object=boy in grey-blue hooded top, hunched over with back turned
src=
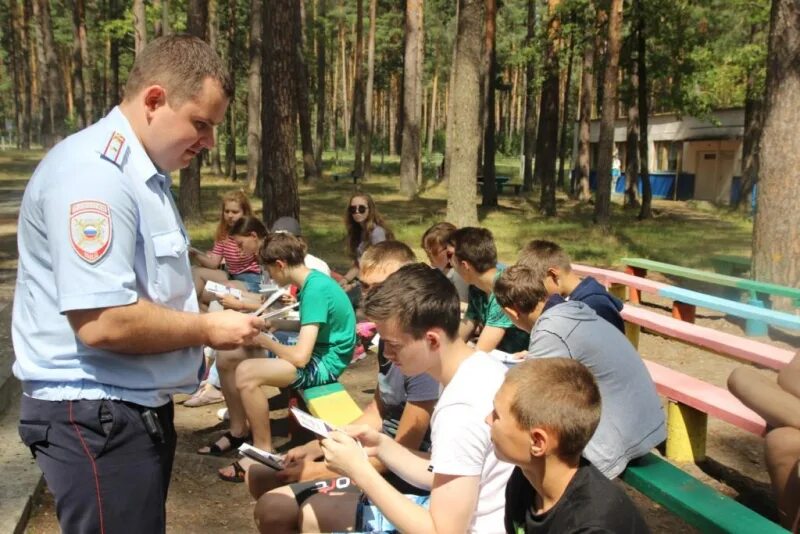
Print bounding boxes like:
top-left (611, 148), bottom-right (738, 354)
top-left (494, 265), bottom-right (667, 478)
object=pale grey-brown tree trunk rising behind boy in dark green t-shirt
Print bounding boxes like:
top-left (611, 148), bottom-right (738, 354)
top-left (445, 0), bottom-right (483, 227)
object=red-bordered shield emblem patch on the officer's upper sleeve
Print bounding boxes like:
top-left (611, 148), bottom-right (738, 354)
top-left (69, 200), bottom-right (111, 263)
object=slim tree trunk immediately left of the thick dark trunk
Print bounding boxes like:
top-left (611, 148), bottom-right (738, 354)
top-left (247, 0), bottom-right (263, 193)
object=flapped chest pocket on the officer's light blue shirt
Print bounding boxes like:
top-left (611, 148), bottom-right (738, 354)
top-left (150, 228), bottom-right (194, 303)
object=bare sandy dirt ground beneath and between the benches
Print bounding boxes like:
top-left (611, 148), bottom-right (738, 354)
top-left (27, 302), bottom-right (800, 534)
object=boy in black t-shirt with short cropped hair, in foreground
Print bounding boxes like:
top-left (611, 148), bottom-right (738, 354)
top-left (487, 358), bottom-right (649, 534)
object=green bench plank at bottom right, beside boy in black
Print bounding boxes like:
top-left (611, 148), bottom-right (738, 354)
top-left (621, 453), bottom-right (787, 534)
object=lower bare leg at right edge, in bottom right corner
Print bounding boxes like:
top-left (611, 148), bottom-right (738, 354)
top-left (765, 427), bottom-right (800, 529)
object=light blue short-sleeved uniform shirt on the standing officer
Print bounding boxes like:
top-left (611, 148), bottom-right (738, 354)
top-left (12, 108), bottom-right (203, 407)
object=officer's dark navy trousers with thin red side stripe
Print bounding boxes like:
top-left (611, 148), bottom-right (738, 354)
top-left (19, 396), bottom-right (177, 534)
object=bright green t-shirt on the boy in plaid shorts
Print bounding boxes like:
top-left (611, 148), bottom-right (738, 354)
top-left (297, 270), bottom-right (356, 377)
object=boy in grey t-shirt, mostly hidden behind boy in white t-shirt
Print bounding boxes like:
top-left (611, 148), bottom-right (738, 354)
top-left (247, 241), bottom-right (439, 533)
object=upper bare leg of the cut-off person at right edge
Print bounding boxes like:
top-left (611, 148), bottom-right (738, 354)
top-left (728, 366), bottom-right (800, 428)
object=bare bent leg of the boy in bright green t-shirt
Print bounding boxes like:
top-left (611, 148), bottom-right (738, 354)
top-left (239, 358), bottom-right (297, 451)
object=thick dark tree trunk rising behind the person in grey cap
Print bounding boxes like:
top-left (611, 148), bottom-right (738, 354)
top-left (261, 0), bottom-right (300, 227)
